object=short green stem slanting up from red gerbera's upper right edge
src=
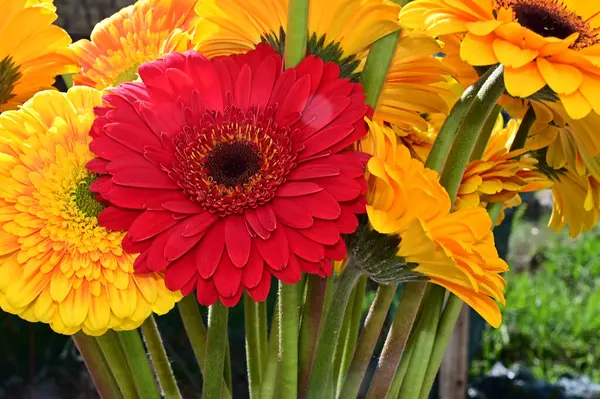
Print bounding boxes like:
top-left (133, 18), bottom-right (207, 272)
top-left (361, 31), bottom-right (400, 108)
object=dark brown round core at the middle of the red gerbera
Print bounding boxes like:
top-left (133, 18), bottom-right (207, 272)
top-left (206, 142), bottom-right (260, 187)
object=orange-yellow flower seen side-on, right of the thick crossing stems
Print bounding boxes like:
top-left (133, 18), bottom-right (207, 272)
top-left (454, 115), bottom-right (552, 209)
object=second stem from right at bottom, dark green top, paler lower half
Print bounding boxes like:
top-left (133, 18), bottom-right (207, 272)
top-left (399, 285), bottom-right (446, 399)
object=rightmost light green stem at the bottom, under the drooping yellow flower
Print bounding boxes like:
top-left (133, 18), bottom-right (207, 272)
top-left (418, 294), bottom-right (464, 399)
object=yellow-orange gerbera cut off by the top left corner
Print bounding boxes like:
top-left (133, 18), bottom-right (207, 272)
top-left (0, 0), bottom-right (77, 112)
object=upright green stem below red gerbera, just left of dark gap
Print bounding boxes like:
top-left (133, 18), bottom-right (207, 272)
top-left (202, 301), bottom-right (229, 399)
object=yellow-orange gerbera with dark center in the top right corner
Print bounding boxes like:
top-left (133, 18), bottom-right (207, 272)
top-left (400, 0), bottom-right (600, 119)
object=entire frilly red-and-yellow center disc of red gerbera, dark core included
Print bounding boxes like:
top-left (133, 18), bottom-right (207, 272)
top-left (171, 106), bottom-right (296, 216)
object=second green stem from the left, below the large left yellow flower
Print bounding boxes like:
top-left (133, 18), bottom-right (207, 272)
top-left (96, 330), bottom-right (138, 399)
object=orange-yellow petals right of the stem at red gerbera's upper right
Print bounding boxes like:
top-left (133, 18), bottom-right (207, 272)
top-left (374, 33), bottom-right (454, 132)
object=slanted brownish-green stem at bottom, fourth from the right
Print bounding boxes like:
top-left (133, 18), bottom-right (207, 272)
top-left (339, 284), bottom-right (398, 399)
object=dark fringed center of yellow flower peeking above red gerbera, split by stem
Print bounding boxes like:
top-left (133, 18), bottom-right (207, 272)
top-left (261, 28), bottom-right (360, 82)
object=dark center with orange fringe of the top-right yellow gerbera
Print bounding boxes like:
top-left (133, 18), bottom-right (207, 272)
top-left (495, 0), bottom-right (600, 49)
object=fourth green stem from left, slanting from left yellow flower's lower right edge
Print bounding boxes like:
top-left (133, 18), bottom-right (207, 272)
top-left (141, 315), bottom-right (181, 399)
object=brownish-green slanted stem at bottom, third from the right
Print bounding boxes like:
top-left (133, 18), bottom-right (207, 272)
top-left (367, 282), bottom-right (426, 399)
